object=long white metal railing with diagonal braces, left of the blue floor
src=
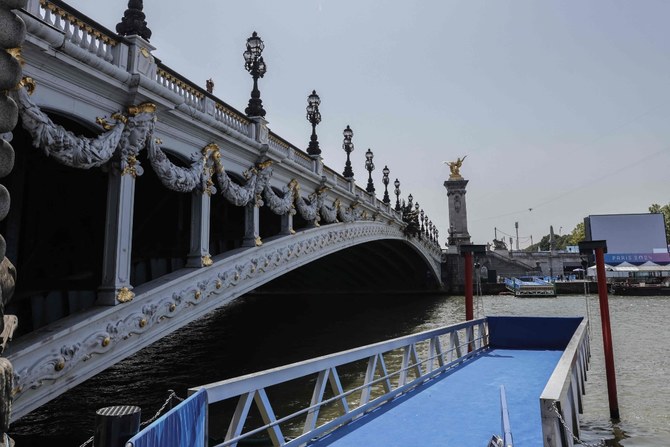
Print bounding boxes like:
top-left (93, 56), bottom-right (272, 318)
top-left (189, 318), bottom-right (488, 447)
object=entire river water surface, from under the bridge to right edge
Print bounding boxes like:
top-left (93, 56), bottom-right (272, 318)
top-left (10, 294), bottom-right (670, 447)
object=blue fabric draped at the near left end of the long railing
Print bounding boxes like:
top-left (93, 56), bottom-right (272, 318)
top-left (128, 390), bottom-right (207, 447)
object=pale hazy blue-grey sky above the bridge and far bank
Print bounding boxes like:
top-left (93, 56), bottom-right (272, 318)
top-left (66, 0), bottom-right (670, 248)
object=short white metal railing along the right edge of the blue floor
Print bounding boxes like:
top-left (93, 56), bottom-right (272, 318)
top-left (540, 319), bottom-right (591, 447)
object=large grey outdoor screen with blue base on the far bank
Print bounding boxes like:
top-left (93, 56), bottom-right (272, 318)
top-left (584, 214), bottom-right (668, 262)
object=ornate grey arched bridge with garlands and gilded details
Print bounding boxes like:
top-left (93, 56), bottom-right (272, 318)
top-left (2, 0), bottom-right (440, 420)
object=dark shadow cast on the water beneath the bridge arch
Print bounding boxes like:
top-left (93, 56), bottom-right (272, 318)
top-left (10, 293), bottom-right (452, 447)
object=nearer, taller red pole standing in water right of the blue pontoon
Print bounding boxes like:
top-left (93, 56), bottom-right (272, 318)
top-left (595, 248), bottom-right (619, 419)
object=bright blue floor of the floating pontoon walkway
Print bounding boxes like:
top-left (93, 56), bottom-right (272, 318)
top-left (310, 349), bottom-right (563, 447)
